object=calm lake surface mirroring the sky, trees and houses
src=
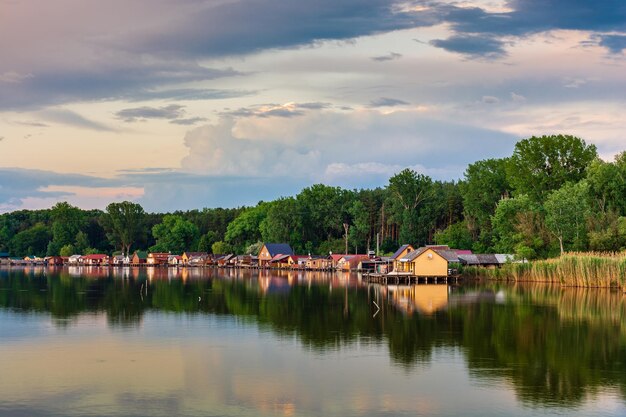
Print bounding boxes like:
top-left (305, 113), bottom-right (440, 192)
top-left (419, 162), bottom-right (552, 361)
top-left (0, 268), bottom-right (626, 417)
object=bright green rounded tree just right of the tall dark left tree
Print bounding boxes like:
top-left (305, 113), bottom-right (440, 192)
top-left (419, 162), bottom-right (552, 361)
top-left (150, 214), bottom-right (199, 253)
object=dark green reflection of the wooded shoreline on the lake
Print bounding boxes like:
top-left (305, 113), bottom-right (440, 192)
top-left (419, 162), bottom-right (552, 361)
top-left (0, 268), bottom-right (626, 406)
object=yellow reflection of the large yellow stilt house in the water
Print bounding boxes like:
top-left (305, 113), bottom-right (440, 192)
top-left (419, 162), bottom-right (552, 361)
top-left (387, 284), bottom-right (448, 315)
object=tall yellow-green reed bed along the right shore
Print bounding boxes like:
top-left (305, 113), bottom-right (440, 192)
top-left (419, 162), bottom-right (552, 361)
top-left (462, 252), bottom-right (626, 289)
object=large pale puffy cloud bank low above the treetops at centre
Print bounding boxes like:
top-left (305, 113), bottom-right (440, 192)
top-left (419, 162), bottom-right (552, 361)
top-left (181, 109), bottom-right (515, 187)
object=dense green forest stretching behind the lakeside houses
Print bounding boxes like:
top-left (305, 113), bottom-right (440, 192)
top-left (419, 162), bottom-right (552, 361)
top-left (0, 135), bottom-right (626, 259)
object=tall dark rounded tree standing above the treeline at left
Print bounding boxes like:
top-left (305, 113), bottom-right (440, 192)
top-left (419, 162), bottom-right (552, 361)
top-left (100, 201), bottom-right (146, 254)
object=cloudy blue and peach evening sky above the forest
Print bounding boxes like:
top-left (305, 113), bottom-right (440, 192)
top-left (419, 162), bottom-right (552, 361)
top-left (0, 0), bottom-right (626, 212)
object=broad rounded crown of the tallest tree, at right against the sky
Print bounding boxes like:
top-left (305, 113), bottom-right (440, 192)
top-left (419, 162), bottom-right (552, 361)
top-left (506, 135), bottom-right (598, 202)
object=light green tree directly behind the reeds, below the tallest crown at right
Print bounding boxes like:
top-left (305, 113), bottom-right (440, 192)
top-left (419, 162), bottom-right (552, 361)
top-left (544, 181), bottom-right (590, 255)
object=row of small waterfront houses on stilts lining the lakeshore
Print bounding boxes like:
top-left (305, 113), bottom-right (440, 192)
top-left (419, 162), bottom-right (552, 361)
top-left (0, 243), bottom-right (512, 283)
